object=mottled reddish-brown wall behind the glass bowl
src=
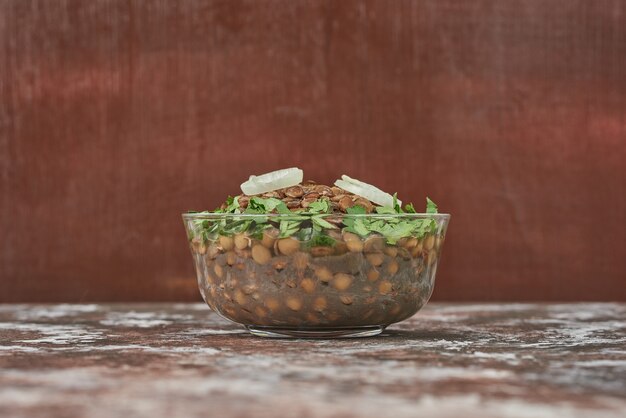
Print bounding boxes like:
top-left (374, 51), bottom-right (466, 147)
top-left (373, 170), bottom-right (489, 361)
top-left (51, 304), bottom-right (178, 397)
top-left (0, 0), bottom-right (626, 302)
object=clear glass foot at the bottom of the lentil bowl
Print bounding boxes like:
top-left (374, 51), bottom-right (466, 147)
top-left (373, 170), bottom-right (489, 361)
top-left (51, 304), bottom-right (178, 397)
top-left (245, 325), bottom-right (385, 338)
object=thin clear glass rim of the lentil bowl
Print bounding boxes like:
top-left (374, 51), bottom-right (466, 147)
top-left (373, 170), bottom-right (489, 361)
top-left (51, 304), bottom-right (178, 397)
top-left (182, 212), bottom-right (451, 220)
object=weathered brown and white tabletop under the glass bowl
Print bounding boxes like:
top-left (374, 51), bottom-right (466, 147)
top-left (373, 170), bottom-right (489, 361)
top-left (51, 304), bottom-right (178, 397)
top-left (0, 303), bottom-right (626, 418)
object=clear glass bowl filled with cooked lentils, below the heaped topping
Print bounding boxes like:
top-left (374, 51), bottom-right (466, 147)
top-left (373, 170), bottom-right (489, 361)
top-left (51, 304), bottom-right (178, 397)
top-left (183, 213), bottom-right (450, 338)
